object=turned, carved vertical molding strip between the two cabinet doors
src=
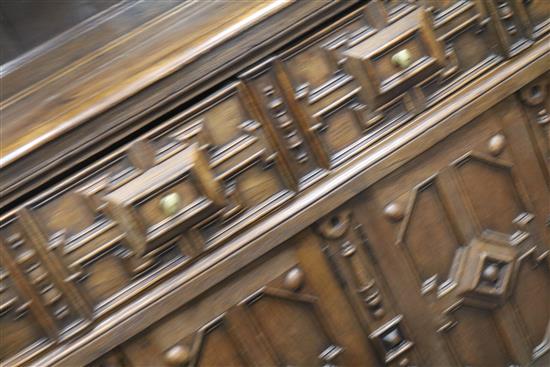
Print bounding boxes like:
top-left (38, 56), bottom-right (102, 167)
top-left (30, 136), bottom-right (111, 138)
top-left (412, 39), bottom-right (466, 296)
top-left (316, 208), bottom-right (418, 366)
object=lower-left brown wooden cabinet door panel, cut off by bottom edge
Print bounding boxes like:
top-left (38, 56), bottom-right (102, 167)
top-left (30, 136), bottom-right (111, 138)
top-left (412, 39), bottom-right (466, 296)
top-left (88, 231), bottom-right (378, 366)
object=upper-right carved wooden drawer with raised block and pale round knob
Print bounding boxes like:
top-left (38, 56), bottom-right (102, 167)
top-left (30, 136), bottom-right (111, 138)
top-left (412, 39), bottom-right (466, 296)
top-left (275, 1), bottom-right (516, 167)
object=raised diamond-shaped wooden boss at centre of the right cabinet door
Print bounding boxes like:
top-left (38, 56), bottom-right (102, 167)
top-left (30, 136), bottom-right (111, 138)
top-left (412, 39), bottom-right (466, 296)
top-left (457, 238), bottom-right (517, 308)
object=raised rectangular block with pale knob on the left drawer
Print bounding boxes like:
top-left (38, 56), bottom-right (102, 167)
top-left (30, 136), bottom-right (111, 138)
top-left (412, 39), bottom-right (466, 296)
top-left (104, 143), bottom-right (224, 256)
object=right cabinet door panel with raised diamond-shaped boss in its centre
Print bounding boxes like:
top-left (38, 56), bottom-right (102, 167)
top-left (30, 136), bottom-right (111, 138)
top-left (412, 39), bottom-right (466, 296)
top-left (358, 97), bottom-right (550, 366)
